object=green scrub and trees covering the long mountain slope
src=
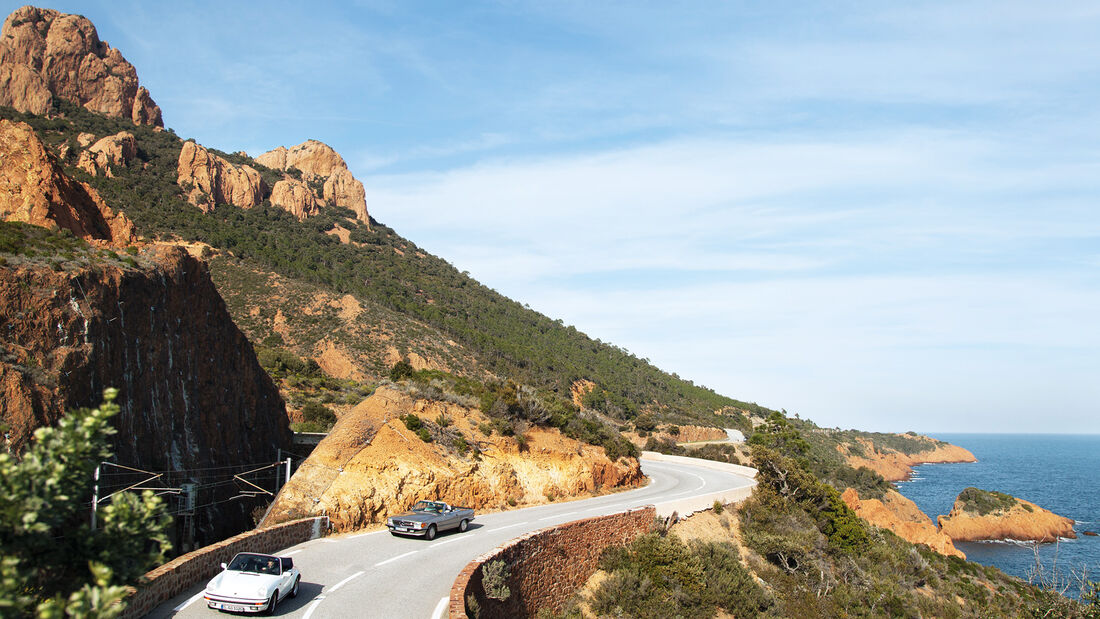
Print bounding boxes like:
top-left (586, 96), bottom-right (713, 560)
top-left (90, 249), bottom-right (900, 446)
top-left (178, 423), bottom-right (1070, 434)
top-left (0, 100), bottom-right (767, 425)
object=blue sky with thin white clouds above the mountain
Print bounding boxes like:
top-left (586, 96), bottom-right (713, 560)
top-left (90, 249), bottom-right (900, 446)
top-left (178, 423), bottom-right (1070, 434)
top-left (19, 1), bottom-right (1100, 432)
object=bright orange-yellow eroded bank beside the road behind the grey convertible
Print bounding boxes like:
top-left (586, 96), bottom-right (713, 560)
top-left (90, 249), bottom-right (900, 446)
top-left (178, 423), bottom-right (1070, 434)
top-left (267, 387), bottom-right (642, 530)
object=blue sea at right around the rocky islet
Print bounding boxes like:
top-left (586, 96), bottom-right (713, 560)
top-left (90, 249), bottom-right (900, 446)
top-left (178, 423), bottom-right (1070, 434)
top-left (895, 433), bottom-right (1100, 597)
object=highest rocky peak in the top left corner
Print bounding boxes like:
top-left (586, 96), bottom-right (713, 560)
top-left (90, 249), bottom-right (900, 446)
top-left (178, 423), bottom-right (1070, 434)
top-left (0, 7), bottom-right (164, 126)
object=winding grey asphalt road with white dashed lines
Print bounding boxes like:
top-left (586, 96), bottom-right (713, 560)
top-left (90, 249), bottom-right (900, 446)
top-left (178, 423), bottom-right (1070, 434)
top-left (146, 458), bottom-right (755, 619)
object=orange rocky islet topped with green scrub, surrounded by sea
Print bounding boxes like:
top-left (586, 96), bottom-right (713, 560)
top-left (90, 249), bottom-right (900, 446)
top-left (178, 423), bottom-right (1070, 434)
top-left (938, 488), bottom-right (1077, 542)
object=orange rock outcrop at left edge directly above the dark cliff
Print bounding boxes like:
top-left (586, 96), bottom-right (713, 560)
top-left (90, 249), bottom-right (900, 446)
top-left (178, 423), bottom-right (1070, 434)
top-left (0, 120), bottom-right (133, 245)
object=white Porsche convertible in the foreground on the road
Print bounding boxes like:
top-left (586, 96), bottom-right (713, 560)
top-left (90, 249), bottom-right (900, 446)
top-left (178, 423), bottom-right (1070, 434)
top-left (202, 552), bottom-right (301, 615)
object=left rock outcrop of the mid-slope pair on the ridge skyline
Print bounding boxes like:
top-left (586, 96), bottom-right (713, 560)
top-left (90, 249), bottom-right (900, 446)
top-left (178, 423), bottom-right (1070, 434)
top-left (176, 142), bottom-right (266, 212)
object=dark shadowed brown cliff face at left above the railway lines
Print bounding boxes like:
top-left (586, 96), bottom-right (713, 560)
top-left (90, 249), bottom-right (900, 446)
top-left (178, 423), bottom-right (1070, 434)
top-left (0, 245), bottom-right (292, 543)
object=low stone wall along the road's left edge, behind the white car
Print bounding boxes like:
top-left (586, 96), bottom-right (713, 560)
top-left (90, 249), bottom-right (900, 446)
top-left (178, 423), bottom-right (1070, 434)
top-left (122, 516), bottom-right (329, 619)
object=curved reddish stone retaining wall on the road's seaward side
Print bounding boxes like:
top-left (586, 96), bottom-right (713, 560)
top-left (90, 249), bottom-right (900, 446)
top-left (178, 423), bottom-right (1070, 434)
top-left (450, 506), bottom-right (657, 619)
